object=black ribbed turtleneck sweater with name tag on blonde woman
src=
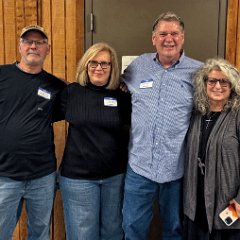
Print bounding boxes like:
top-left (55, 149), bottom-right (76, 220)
top-left (61, 83), bottom-right (131, 179)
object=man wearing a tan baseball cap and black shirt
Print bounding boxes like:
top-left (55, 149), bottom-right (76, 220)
top-left (0, 25), bottom-right (66, 240)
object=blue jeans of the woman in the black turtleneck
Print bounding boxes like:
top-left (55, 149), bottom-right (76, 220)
top-left (60, 174), bottom-right (125, 240)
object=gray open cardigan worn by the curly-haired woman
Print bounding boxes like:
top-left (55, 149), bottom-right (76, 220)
top-left (183, 110), bottom-right (240, 231)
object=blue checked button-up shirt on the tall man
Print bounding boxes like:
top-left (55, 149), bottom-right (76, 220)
top-left (123, 53), bottom-right (201, 183)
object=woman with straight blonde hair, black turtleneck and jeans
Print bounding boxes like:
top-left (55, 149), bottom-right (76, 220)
top-left (60, 43), bottom-right (131, 240)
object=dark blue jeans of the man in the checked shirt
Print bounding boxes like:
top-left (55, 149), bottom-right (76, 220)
top-left (123, 166), bottom-right (182, 240)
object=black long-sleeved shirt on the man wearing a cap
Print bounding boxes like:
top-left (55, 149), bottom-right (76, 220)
top-left (0, 64), bottom-right (66, 180)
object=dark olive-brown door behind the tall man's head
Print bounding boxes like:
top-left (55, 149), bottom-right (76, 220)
top-left (85, 0), bottom-right (227, 64)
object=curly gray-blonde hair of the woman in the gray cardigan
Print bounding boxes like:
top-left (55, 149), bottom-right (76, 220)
top-left (193, 58), bottom-right (240, 115)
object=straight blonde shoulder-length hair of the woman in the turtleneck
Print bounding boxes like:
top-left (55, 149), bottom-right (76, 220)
top-left (76, 42), bottom-right (120, 90)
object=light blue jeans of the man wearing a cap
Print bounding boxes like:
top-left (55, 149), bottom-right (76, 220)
top-left (0, 172), bottom-right (56, 240)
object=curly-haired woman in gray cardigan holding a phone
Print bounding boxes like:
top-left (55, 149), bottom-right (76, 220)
top-left (183, 58), bottom-right (240, 240)
